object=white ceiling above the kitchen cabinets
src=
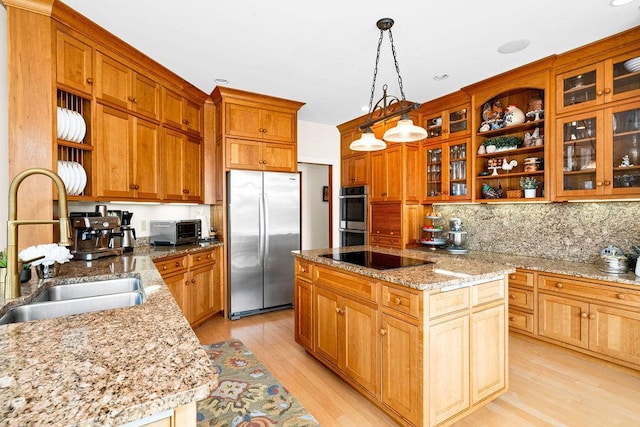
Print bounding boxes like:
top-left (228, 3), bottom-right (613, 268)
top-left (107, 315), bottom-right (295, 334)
top-left (64, 0), bottom-right (640, 125)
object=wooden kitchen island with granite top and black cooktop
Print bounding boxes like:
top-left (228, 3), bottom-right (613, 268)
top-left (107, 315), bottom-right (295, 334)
top-left (294, 246), bottom-right (515, 426)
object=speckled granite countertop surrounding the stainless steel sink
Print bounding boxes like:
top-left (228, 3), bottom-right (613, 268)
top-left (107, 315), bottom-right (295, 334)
top-left (0, 243), bottom-right (221, 426)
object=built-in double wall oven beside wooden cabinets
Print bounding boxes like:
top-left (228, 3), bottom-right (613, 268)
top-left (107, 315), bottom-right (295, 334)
top-left (339, 185), bottom-right (368, 246)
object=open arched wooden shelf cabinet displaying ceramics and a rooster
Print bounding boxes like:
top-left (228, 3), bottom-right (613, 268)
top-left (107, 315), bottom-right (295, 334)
top-left (466, 57), bottom-right (554, 202)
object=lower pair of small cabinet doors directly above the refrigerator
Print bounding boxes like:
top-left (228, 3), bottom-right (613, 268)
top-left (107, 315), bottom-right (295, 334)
top-left (226, 138), bottom-right (297, 172)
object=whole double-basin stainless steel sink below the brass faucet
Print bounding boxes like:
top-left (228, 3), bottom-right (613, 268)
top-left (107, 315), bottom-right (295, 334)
top-left (0, 278), bottom-right (146, 325)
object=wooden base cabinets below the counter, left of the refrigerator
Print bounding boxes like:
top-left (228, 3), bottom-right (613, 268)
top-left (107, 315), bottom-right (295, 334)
top-left (154, 247), bottom-right (223, 327)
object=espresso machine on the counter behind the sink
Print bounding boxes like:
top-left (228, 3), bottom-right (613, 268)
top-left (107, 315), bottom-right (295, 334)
top-left (69, 212), bottom-right (123, 260)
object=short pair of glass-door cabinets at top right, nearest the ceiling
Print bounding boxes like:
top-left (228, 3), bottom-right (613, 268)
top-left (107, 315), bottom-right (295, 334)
top-left (556, 50), bottom-right (640, 114)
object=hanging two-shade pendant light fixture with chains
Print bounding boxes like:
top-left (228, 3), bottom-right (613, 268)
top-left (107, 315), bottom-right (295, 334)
top-left (349, 18), bottom-right (427, 151)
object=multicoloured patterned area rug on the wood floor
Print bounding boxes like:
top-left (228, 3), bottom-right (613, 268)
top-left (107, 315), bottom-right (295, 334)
top-left (198, 340), bottom-right (319, 427)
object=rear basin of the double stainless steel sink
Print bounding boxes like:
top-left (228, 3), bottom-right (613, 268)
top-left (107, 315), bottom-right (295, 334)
top-left (33, 277), bottom-right (143, 302)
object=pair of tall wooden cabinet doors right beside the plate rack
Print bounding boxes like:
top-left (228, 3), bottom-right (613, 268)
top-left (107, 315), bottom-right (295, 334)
top-left (96, 104), bottom-right (160, 200)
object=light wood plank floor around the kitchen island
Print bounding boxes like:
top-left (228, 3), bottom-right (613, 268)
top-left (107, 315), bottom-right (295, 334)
top-left (195, 310), bottom-right (640, 427)
